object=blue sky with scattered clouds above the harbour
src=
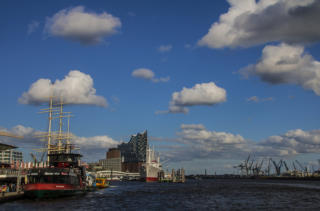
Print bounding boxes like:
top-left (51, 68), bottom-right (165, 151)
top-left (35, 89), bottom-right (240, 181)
top-left (0, 0), bottom-right (320, 173)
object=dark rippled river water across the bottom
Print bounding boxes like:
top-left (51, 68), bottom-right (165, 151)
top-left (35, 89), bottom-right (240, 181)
top-left (0, 179), bottom-right (320, 211)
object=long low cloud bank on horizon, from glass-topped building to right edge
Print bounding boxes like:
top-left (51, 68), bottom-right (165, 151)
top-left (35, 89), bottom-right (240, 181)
top-left (164, 124), bottom-right (320, 161)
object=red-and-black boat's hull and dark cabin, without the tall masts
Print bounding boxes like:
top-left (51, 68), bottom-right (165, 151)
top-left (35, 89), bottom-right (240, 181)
top-left (24, 153), bottom-right (85, 198)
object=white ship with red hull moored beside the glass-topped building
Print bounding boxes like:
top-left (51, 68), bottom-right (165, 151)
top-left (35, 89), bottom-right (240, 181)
top-left (142, 147), bottom-right (162, 182)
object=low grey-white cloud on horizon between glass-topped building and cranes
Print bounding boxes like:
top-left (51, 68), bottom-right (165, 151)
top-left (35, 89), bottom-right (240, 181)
top-left (164, 124), bottom-right (249, 161)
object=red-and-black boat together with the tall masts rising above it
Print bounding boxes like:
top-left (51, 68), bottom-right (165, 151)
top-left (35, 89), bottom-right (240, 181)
top-left (24, 97), bottom-right (86, 198)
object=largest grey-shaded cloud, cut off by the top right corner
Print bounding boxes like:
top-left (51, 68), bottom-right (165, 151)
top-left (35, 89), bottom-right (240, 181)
top-left (198, 0), bottom-right (320, 48)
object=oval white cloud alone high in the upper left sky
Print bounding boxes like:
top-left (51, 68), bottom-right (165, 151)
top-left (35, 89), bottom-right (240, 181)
top-left (45, 6), bottom-right (121, 45)
